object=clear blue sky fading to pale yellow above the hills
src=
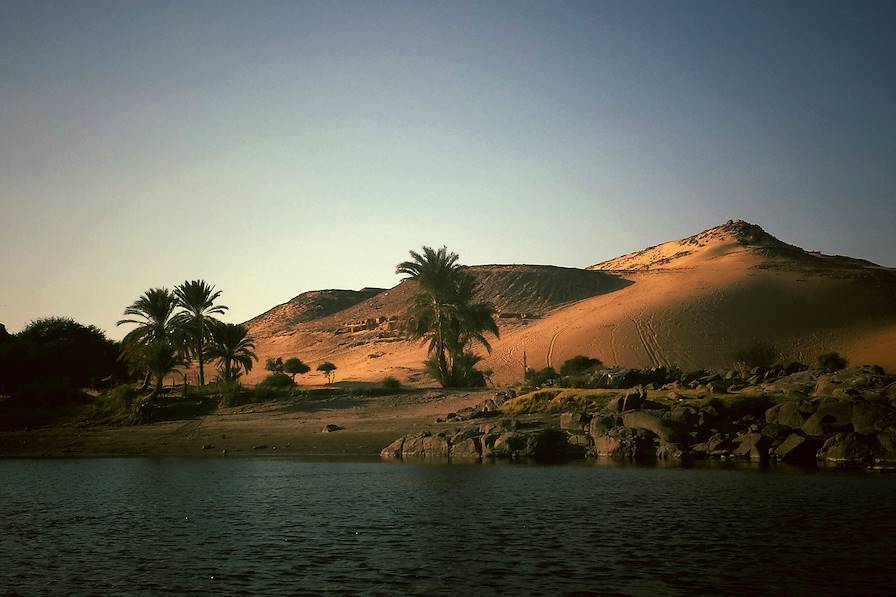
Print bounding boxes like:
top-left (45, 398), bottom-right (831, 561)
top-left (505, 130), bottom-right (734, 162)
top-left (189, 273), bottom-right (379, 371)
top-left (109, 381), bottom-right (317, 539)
top-left (0, 0), bottom-right (896, 338)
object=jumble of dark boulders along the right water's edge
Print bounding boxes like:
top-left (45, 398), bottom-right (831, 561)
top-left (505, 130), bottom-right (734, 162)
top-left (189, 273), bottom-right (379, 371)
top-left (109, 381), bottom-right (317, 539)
top-left (381, 366), bottom-right (896, 470)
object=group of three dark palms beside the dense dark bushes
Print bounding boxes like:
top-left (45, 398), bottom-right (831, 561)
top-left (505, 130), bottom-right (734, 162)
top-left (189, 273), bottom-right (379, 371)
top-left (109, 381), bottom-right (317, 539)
top-left (117, 280), bottom-right (258, 395)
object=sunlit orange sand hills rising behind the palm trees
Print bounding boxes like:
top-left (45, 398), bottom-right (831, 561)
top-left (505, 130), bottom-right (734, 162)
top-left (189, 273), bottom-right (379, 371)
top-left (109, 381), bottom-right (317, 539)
top-left (240, 221), bottom-right (896, 383)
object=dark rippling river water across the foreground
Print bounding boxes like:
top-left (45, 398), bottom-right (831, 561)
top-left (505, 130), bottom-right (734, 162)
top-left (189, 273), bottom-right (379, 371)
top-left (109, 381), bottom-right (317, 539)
top-left (0, 458), bottom-right (896, 595)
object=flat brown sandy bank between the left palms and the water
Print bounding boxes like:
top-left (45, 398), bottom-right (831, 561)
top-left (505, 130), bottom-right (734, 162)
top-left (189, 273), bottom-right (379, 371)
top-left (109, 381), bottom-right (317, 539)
top-left (0, 390), bottom-right (494, 457)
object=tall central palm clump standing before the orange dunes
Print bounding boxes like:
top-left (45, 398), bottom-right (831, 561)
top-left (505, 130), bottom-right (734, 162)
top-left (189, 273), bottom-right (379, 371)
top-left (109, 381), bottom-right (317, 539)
top-left (395, 247), bottom-right (499, 387)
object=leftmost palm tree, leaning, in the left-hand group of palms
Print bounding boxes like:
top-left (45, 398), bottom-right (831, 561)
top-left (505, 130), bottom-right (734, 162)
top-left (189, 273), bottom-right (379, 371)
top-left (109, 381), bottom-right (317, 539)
top-left (115, 288), bottom-right (177, 388)
